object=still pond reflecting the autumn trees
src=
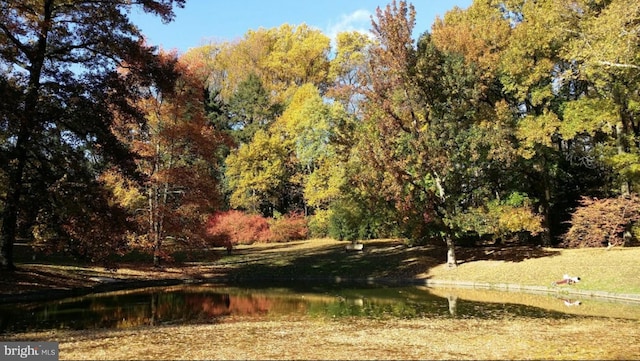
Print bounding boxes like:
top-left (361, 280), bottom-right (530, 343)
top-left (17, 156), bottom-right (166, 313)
top-left (0, 284), bottom-right (640, 334)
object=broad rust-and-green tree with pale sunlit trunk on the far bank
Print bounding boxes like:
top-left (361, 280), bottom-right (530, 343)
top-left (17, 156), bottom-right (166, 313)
top-left (363, 2), bottom-right (539, 266)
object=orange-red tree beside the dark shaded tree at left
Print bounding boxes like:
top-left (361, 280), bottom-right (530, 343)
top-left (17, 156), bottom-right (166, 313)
top-left (113, 53), bottom-right (226, 266)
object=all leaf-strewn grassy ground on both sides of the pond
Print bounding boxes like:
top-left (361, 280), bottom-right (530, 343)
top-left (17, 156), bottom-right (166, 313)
top-left (0, 240), bottom-right (640, 360)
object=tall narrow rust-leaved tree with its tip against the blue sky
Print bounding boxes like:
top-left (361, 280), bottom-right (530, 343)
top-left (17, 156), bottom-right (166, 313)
top-left (363, 1), bottom-right (468, 266)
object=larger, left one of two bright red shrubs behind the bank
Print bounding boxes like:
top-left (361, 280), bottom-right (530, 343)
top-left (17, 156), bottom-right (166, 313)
top-left (207, 210), bottom-right (269, 247)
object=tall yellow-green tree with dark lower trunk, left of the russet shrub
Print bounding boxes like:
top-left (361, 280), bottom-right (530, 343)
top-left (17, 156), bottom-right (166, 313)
top-left (495, 1), bottom-right (571, 245)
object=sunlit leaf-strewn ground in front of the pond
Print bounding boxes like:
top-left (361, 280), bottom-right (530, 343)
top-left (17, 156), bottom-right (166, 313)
top-left (8, 318), bottom-right (640, 360)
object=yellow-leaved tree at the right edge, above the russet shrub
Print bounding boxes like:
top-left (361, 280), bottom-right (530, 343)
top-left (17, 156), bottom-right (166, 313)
top-left (561, 0), bottom-right (640, 195)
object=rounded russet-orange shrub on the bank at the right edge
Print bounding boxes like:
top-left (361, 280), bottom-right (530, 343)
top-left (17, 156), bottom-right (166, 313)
top-left (563, 194), bottom-right (640, 247)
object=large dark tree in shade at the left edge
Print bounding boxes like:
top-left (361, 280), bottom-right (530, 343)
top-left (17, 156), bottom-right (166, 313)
top-left (0, 0), bottom-right (184, 269)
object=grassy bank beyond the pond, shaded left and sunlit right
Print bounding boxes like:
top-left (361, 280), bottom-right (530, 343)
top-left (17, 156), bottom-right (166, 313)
top-left (0, 239), bottom-right (640, 295)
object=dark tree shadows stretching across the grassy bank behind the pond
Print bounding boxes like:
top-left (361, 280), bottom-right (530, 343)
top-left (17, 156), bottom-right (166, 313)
top-left (0, 240), bottom-right (559, 298)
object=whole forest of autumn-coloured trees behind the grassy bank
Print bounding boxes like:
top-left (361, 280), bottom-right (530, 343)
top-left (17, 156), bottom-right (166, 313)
top-left (0, 0), bottom-right (640, 270)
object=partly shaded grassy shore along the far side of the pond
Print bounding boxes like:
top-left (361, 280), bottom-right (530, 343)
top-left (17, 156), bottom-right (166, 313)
top-left (0, 239), bottom-right (640, 304)
